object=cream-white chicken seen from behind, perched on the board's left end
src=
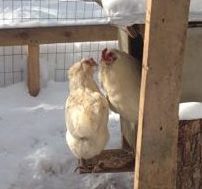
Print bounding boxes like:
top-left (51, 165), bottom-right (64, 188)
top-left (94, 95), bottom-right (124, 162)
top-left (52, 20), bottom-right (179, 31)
top-left (65, 58), bottom-right (109, 167)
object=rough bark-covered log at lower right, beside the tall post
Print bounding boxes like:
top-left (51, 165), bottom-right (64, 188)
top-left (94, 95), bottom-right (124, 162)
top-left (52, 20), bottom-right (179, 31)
top-left (177, 120), bottom-right (202, 189)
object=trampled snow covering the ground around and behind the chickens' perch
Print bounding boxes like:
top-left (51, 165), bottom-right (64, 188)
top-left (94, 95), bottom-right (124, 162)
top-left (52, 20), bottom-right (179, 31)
top-left (0, 81), bottom-right (133, 189)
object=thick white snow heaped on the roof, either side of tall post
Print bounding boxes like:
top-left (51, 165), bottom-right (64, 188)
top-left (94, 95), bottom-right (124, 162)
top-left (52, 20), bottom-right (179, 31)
top-left (102, 0), bottom-right (202, 26)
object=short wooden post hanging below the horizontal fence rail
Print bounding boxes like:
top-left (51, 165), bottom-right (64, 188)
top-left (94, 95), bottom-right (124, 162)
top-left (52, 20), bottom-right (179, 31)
top-left (27, 44), bottom-right (40, 96)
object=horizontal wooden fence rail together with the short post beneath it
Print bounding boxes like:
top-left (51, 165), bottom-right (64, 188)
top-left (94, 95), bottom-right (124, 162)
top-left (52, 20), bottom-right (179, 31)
top-left (0, 24), bottom-right (118, 96)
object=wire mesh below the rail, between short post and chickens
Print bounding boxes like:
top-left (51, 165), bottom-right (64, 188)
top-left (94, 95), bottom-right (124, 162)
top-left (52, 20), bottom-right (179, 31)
top-left (40, 41), bottom-right (118, 81)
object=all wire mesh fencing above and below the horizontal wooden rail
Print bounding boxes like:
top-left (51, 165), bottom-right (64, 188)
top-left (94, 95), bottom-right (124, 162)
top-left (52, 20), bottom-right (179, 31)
top-left (0, 0), bottom-right (118, 87)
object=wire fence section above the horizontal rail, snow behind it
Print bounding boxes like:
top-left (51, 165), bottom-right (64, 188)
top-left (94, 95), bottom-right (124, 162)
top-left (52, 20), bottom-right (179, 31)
top-left (0, 0), bottom-right (106, 27)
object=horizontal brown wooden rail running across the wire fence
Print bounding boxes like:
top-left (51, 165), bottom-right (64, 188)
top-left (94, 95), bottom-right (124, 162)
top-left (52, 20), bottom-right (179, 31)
top-left (0, 25), bottom-right (117, 46)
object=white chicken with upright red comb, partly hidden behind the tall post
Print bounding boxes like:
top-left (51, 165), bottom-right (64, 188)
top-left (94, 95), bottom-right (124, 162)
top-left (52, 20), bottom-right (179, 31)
top-left (99, 49), bottom-right (141, 134)
